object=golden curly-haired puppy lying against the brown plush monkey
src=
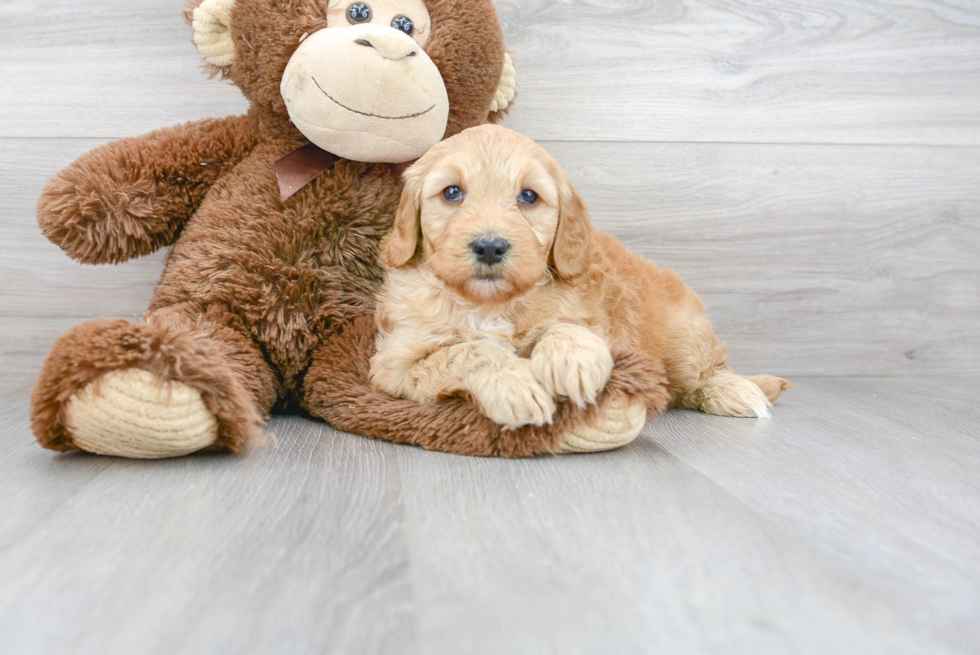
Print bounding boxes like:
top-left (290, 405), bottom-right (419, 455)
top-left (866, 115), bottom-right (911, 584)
top-left (371, 125), bottom-right (789, 428)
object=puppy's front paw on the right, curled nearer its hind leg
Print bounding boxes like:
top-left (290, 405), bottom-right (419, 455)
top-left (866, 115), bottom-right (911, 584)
top-left (531, 323), bottom-right (613, 407)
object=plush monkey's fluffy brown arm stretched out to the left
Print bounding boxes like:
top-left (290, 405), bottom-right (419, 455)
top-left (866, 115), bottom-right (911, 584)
top-left (37, 116), bottom-right (257, 264)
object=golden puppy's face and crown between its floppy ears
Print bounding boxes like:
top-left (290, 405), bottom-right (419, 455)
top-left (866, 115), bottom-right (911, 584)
top-left (409, 126), bottom-right (559, 304)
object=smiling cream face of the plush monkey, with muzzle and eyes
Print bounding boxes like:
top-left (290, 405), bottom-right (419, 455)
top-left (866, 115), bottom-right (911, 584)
top-left (280, 0), bottom-right (449, 163)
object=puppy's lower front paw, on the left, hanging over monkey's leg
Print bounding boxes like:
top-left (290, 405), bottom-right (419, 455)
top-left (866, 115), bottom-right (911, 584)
top-left (471, 360), bottom-right (555, 430)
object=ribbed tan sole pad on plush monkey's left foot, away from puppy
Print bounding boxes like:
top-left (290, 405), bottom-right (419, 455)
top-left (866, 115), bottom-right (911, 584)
top-left (66, 368), bottom-right (218, 459)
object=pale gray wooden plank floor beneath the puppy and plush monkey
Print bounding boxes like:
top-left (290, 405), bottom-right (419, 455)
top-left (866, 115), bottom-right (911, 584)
top-left (0, 378), bottom-right (980, 655)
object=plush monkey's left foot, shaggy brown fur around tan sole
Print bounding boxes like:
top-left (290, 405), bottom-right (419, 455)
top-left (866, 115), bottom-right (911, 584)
top-left (31, 319), bottom-right (263, 459)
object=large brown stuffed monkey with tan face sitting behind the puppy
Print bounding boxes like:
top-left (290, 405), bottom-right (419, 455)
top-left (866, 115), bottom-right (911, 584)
top-left (31, 0), bottom-right (667, 458)
